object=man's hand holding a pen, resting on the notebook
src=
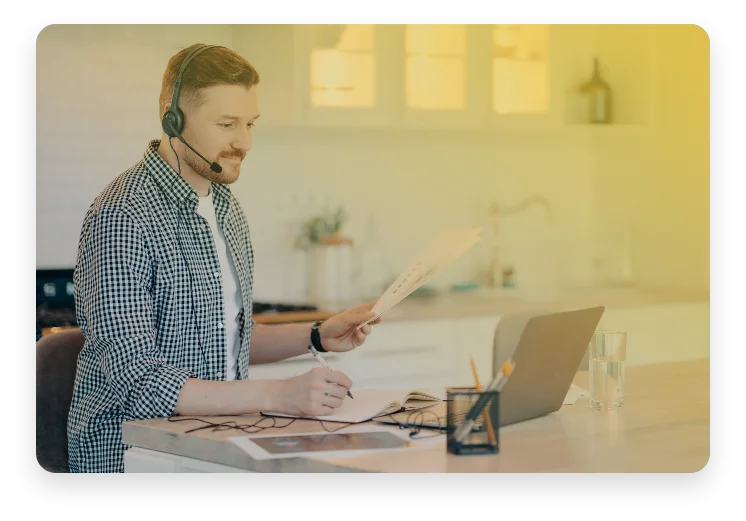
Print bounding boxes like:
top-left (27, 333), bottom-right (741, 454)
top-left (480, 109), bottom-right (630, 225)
top-left (278, 367), bottom-right (352, 416)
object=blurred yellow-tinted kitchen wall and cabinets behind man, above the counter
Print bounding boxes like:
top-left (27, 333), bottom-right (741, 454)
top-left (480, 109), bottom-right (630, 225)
top-left (36, 24), bottom-right (710, 303)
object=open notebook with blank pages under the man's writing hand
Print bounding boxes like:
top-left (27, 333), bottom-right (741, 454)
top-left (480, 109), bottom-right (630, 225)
top-left (262, 389), bottom-right (441, 423)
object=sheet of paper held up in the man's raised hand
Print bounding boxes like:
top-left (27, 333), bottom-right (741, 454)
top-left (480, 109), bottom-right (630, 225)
top-left (358, 228), bottom-right (482, 329)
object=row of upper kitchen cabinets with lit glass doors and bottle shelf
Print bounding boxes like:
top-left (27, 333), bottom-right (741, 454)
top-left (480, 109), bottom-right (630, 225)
top-left (233, 24), bottom-right (655, 135)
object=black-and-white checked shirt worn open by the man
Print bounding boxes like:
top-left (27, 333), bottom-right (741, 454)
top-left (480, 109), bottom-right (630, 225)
top-left (67, 140), bottom-right (254, 472)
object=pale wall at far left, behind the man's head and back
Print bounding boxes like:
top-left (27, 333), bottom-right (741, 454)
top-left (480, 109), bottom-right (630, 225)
top-left (36, 24), bottom-right (232, 268)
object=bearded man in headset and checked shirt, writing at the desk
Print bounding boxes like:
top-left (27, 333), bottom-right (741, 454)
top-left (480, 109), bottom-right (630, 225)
top-left (68, 44), bottom-right (380, 472)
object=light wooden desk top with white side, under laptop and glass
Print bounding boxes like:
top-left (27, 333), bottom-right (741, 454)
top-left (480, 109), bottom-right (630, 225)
top-left (123, 358), bottom-right (710, 472)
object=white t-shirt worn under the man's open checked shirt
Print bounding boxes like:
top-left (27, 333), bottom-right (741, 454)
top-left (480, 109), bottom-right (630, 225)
top-left (197, 188), bottom-right (243, 380)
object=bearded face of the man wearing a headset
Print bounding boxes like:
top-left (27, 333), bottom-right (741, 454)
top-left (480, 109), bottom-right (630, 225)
top-left (179, 85), bottom-right (259, 185)
